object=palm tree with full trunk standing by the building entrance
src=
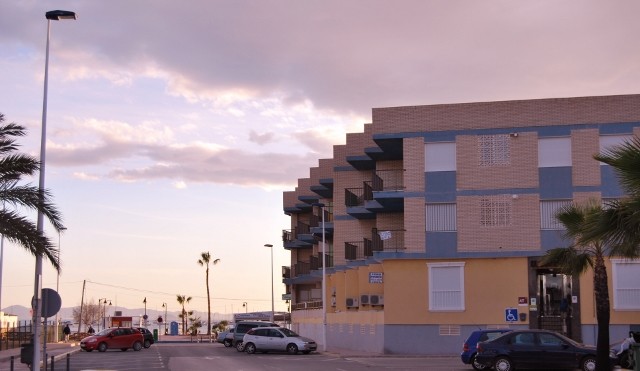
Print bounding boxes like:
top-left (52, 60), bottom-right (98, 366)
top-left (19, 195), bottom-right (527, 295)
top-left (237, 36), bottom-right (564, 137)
top-left (541, 200), bottom-right (616, 370)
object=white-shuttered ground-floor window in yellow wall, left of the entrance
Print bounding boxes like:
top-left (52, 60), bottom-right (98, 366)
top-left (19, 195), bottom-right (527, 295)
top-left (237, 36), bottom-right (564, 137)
top-left (427, 262), bottom-right (464, 311)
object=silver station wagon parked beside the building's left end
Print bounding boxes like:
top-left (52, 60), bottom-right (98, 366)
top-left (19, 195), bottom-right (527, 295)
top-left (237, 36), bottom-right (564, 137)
top-left (242, 327), bottom-right (318, 354)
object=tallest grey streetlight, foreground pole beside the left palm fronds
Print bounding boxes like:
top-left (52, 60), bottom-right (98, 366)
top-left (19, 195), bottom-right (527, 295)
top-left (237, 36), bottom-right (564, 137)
top-left (31, 10), bottom-right (77, 367)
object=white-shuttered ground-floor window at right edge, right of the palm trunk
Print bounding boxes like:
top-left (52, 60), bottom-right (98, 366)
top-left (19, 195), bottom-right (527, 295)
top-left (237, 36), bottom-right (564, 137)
top-left (611, 259), bottom-right (640, 310)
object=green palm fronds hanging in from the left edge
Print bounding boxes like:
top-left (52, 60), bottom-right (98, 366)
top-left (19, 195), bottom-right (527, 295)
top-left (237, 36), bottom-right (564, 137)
top-left (0, 113), bottom-right (64, 271)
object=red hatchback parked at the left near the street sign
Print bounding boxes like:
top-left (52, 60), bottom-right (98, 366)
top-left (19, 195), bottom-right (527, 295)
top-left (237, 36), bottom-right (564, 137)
top-left (80, 327), bottom-right (144, 352)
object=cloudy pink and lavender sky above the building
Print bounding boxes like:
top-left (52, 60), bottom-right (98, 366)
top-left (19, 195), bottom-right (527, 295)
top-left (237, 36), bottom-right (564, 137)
top-left (0, 0), bottom-right (640, 322)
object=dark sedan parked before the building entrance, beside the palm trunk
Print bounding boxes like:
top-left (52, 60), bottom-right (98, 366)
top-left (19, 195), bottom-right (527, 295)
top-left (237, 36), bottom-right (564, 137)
top-left (476, 330), bottom-right (615, 371)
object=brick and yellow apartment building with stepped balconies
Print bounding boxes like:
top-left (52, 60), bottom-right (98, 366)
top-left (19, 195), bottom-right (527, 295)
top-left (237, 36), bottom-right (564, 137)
top-left (283, 95), bottom-right (640, 354)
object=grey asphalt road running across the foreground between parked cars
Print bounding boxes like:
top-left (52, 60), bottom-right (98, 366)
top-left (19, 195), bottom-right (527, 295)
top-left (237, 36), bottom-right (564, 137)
top-left (55, 343), bottom-right (472, 371)
